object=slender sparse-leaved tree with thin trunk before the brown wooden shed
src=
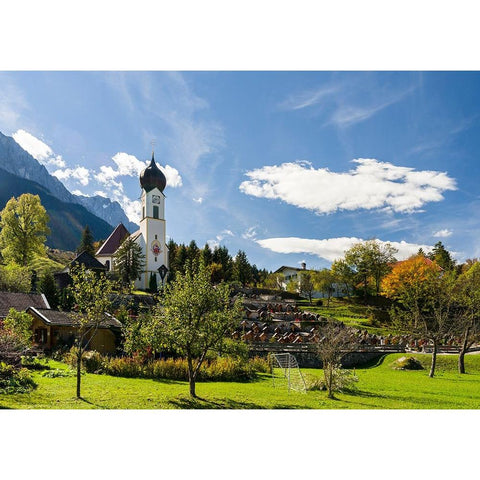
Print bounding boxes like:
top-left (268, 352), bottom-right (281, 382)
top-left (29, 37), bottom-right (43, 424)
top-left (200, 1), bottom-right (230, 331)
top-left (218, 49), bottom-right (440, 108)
top-left (69, 265), bottom-right (114, 398)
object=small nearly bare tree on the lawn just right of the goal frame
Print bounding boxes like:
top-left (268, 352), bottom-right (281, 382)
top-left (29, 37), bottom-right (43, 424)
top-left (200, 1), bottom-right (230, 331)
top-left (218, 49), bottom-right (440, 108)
top-left (317, 321), bottom-right (357, 399)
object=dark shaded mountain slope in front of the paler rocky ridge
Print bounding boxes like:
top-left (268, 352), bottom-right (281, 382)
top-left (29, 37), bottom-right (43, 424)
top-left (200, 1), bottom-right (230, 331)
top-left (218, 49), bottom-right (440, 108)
top-left (0, 169), bottom-right (112, 250)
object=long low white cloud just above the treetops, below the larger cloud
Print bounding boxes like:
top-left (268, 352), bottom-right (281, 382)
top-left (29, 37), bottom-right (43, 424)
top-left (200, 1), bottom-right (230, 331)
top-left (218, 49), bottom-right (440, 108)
top-left (256, 237), bottom-right (432, 262)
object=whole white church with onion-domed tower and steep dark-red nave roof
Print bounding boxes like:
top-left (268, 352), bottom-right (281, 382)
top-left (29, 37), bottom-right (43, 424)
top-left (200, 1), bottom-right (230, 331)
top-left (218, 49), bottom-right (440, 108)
top-left (95, 152), bottom-right (168, 290)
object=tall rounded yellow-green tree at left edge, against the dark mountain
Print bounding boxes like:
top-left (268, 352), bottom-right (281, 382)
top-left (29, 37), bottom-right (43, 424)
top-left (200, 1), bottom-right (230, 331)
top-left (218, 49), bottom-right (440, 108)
top-left (0, 193), bottom-right (50, 267)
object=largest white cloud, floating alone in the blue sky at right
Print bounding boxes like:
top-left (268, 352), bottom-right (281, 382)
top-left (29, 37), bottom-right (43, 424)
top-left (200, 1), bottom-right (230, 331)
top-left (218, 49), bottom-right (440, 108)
top-left (239, 158), bottom-right (456, 214)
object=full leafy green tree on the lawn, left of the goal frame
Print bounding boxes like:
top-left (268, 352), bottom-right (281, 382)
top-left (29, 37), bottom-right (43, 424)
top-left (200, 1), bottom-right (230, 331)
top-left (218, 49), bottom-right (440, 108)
top-left (150, 262), bottom-right (242, 398)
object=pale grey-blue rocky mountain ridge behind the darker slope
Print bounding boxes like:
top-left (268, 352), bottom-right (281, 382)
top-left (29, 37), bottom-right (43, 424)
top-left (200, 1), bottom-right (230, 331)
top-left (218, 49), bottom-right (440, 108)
top-left (0, 132), bottom-right (138, 232)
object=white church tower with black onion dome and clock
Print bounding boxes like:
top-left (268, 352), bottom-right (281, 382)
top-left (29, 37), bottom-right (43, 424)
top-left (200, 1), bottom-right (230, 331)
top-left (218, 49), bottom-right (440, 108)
top-left (135, 152), bottom-right (168, 290)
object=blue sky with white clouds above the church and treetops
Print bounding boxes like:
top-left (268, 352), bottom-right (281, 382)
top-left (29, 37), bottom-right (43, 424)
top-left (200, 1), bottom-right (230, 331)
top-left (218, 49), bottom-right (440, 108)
top-left (0, 72), bottom-right (480, 270)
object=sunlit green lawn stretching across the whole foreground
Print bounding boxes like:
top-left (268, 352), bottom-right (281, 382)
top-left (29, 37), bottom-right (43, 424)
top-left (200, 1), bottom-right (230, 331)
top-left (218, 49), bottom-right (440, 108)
top-left (0, 354), bottom-right (480, 409)
